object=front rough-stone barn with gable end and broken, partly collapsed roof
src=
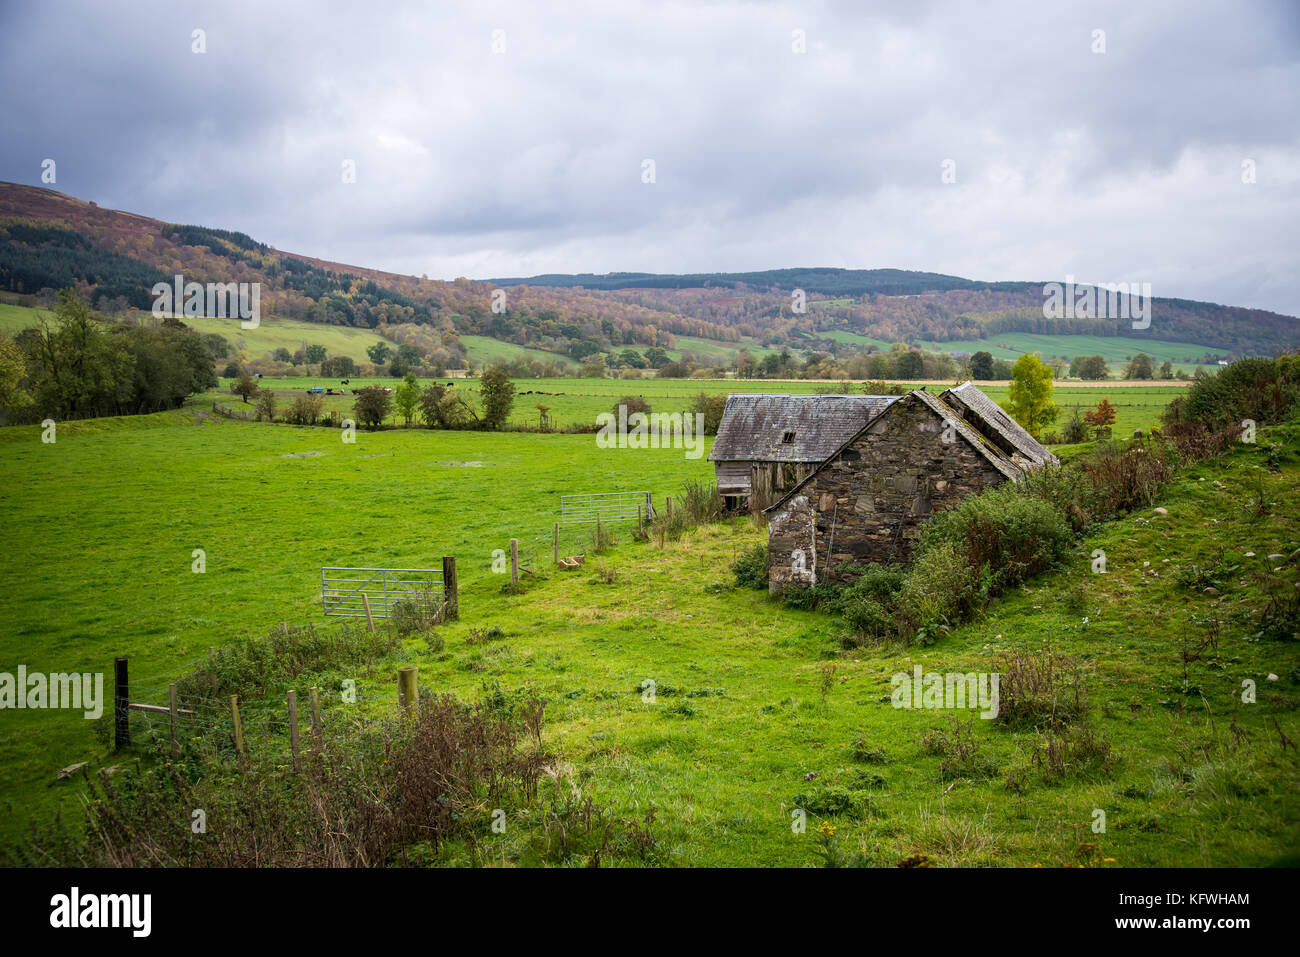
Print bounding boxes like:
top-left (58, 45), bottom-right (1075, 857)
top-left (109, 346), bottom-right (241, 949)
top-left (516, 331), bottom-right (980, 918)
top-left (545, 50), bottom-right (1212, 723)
top-left (766, 382), bottom-right (1057, 593)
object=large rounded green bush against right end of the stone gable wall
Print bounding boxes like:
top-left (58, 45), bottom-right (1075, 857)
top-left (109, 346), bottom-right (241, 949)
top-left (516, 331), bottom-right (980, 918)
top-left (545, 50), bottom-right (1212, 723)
top-left (917, 485), bottom-right (1073, 590)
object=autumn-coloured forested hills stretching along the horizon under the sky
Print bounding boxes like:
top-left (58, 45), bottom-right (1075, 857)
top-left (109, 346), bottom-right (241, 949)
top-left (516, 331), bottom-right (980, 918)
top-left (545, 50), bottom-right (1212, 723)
top-left (0, 183), bottom-right (1300, 363)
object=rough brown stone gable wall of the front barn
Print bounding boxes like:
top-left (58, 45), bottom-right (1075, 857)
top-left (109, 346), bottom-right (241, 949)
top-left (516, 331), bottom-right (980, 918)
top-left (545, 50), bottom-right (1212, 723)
top-left (768, 397), bottom-right (1006, 593)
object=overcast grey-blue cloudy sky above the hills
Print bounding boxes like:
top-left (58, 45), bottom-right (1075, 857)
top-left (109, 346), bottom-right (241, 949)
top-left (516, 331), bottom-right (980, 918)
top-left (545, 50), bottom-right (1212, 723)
top-left (0, 0), bottom-right (1300, 315)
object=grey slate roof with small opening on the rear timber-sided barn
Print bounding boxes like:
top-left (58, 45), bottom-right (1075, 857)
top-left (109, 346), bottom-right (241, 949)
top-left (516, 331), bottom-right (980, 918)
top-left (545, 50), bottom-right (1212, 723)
top-left (709, 393), bottom-right (900, 464)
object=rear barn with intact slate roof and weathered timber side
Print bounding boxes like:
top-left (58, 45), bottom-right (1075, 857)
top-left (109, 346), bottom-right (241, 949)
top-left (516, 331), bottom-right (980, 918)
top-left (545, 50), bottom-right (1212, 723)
top-left (709, 393), bottom-right (898, 508)
